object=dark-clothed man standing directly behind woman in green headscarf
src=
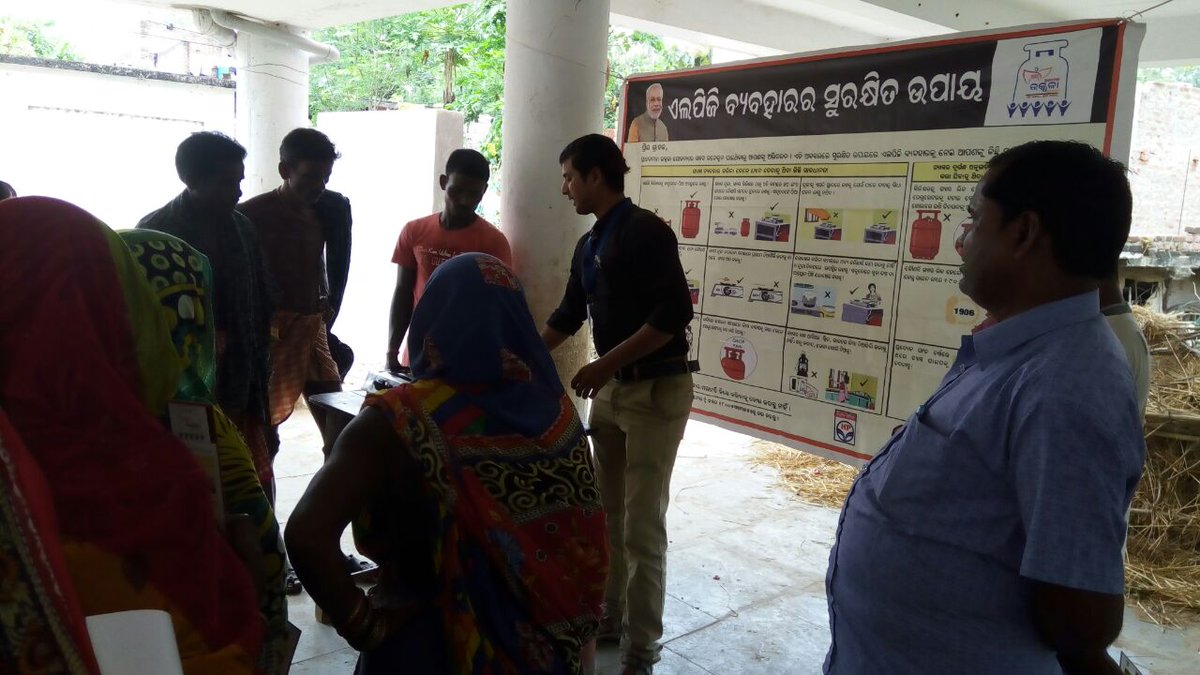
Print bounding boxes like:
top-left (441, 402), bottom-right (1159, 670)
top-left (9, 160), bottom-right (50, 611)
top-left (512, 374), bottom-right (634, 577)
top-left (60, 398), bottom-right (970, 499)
top-left (138, 131), bottom-right (275, 494)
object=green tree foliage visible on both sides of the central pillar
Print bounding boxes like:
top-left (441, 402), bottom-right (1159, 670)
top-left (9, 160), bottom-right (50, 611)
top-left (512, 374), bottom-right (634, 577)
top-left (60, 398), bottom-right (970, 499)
top-left (310, 0), bottom-right (709, 165)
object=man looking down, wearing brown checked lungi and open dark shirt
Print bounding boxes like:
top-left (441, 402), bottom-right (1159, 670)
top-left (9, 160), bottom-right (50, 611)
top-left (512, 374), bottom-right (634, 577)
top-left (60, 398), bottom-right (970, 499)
top-left (239, 129), bottom-right (348, 459)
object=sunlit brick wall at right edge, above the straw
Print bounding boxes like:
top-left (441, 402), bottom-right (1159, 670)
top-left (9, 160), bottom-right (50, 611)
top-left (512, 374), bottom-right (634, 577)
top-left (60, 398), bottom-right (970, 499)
top-left (1129, 82), bottom-right (1200, 237)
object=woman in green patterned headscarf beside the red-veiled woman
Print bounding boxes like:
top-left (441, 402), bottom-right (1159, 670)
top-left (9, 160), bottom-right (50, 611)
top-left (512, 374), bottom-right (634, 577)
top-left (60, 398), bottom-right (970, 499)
top-left (119, 229), bottom-right (288, 674)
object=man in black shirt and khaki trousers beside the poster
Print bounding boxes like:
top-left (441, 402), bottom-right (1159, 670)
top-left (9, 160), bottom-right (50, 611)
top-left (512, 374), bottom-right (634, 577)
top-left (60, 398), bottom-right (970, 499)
top-left (542, 133), bottom-right (697, 675)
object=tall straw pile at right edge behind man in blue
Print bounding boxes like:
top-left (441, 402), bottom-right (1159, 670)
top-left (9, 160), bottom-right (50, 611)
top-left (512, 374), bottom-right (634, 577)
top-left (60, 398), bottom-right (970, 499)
top-left (1126, 307), bottom-right (1200, 625)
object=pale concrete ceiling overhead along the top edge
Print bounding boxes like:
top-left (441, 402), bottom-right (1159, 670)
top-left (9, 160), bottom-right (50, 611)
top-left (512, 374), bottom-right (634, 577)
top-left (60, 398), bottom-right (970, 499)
top-left (103, 0), bottom-right (1200, 64)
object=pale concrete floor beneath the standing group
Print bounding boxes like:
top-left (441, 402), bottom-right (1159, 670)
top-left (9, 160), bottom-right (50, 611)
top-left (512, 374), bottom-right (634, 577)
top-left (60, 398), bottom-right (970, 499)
top-left (275, 401), bottom-right (1200, 675)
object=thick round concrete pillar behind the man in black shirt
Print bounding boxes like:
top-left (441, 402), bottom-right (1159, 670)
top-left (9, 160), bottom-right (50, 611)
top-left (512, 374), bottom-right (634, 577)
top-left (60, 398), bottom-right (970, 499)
top-left (500, 0), bottom-right (608, 381)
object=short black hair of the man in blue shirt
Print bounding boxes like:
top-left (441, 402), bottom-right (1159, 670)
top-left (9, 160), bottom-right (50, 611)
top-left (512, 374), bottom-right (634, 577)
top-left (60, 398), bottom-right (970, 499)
top-left (983, 141), bottom-right (1133, 280)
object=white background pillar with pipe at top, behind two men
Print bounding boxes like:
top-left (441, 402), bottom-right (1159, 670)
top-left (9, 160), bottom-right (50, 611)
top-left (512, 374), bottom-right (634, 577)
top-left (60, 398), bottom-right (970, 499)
top-left (236, 31), bottom-right (310, 197)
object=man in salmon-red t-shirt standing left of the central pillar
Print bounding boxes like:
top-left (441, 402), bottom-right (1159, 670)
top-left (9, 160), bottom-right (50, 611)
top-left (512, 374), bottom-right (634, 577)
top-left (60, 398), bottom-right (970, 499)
top-left (388, 149), bottom-right (512, 370)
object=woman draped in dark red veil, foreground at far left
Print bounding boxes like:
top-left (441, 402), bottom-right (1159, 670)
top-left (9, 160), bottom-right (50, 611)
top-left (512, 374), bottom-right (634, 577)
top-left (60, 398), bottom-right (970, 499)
top-left (0, 197), bottom-right (263, 675)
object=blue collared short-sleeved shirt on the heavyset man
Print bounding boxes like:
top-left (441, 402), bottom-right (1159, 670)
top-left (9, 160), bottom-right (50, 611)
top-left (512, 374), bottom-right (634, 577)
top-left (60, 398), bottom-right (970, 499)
top-left (826, 293), bottom-right (1145, 675)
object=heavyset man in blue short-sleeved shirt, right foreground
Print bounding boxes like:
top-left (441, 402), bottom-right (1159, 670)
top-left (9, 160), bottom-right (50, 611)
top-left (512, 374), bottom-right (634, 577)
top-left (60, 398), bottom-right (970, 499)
top-left (824, 141), bottom-right (1146, 675)
